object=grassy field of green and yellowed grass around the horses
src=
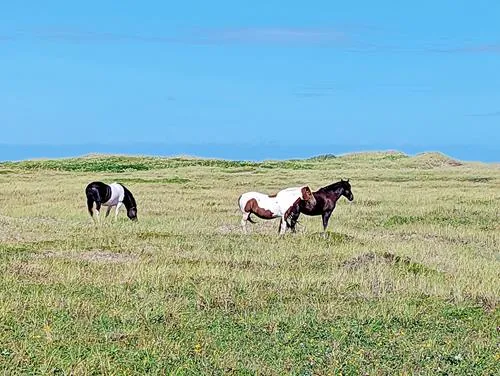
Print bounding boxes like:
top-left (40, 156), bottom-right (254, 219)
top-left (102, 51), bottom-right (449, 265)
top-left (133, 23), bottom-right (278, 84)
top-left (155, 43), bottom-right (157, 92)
top-left (0, 153), bottom-right (500, 375)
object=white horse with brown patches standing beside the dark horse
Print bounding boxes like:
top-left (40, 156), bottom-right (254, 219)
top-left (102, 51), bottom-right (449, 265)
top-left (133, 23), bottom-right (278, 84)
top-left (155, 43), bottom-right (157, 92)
top-left (238, 186), bottom-right (314, 234)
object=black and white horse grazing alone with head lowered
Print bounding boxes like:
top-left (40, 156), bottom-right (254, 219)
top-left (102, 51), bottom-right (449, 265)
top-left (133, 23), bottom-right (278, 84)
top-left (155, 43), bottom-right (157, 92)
top-left (85, 181), bottom-right (137, 221)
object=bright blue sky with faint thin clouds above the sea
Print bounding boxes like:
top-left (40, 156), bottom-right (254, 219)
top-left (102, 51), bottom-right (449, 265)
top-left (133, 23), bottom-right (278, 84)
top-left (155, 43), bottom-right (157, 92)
top-left (0, 0), bottom-right (500, 159)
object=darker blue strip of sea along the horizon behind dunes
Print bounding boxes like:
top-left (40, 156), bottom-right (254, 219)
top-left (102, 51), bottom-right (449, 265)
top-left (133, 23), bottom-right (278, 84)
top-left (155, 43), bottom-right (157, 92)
top-left (0, 143), bottom-right (500, 162)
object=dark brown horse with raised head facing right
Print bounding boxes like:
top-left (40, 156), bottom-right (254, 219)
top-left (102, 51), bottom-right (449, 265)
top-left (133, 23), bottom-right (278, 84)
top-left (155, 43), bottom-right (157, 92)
top-left (288, 179), bottom-right (354, 232)
